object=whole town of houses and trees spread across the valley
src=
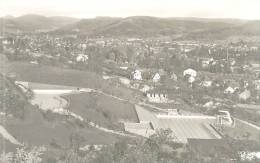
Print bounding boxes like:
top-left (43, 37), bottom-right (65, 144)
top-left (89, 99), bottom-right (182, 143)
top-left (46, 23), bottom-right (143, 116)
top-left (0, 34), bottom-right (260, 105)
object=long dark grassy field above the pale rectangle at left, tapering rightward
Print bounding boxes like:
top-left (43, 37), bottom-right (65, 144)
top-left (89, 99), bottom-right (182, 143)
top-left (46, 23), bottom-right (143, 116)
top-left (8, 62), bottom-right (140, 100)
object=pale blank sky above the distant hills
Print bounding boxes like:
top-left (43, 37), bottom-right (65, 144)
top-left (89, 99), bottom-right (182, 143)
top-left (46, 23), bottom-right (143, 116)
top-left (0, 0), bottom-right (260, 20)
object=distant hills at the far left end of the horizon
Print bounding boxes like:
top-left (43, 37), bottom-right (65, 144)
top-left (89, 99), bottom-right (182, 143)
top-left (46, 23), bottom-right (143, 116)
top-left (0, 15), bottom-right (79, 33)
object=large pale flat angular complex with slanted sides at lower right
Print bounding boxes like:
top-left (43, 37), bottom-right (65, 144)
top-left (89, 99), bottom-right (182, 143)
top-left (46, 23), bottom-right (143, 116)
top-left (125, 105), bottom-right (221, 143)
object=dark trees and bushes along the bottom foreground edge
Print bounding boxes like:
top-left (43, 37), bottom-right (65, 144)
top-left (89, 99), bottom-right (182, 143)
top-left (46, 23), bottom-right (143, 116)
top-left (0, 129), bottom-right (259, 163)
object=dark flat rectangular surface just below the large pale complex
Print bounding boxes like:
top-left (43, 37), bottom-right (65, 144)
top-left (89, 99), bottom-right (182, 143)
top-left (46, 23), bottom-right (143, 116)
top-left (188, 139), bottom-right (235, 158)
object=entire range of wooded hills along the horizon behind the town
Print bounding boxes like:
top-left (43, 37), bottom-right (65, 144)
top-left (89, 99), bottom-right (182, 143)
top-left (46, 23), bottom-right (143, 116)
top-left (0, 15), bottom-right (260, 39)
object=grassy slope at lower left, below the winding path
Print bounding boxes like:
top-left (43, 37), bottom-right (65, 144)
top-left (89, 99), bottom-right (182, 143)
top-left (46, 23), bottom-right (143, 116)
top-left (0, 72), bottom-right (130, 151)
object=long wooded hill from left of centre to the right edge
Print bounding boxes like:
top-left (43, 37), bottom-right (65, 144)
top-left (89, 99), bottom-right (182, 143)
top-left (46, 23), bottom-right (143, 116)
top-left (55, 16), bottom-right (260, 39)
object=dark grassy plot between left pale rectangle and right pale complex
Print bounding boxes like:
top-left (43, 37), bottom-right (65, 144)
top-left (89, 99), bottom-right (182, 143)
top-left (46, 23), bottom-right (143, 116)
top-left (66, 93), bottom-right (138, 130)
